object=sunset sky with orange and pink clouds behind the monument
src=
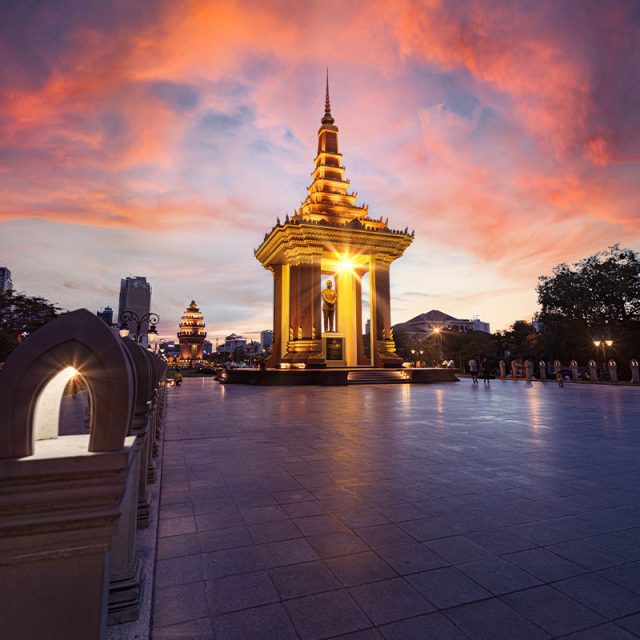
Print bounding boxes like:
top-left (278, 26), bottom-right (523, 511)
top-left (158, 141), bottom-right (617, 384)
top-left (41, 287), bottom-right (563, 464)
top-left (0, 0), bottom-right (640, 338)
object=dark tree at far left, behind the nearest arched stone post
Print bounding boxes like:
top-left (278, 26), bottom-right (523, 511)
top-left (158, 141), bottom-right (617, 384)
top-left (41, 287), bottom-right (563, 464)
top-left (0, 290), bottom-right (60, 361)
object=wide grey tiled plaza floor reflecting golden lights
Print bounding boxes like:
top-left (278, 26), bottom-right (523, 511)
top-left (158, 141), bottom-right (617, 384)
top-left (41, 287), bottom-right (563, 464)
top-left (153, 378), bottom-right (640, 640)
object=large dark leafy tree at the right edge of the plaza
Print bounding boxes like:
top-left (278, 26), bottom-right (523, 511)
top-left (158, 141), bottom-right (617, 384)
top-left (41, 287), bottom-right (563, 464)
top-left (537, 244), bottom-right (640, 366)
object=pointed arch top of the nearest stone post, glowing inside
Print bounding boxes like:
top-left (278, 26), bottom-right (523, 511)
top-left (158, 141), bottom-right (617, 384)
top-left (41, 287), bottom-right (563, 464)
top-left (0, 309), bottom-right (134, 458)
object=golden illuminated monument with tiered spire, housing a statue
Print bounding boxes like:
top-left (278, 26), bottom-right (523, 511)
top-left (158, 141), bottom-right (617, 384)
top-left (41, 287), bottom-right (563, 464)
top-left (255, 77), bottom-right (414, 367)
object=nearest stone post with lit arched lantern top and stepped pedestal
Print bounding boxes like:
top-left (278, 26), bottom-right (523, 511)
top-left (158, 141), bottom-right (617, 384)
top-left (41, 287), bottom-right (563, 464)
top-left (0, 309), bottom-right (137, 640)
